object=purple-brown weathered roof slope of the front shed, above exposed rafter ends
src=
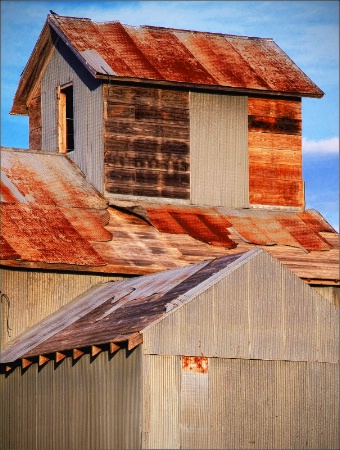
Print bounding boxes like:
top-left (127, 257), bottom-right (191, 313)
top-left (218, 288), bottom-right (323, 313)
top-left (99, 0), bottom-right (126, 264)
top-left (1, 250), bottom-right (254, 363)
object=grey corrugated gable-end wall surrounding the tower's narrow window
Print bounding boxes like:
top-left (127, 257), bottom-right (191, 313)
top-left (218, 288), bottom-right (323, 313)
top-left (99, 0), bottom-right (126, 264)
top-left (41, 41), bottom-right (104, 192)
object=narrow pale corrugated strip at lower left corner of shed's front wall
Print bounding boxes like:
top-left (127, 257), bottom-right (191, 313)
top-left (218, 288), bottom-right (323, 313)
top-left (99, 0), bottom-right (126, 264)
top-left (142, 355), bottom-right (181, 449)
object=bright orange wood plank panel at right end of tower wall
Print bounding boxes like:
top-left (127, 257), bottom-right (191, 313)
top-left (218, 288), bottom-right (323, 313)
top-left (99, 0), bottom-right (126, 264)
top-left (248, 97), bottom-right (304, 208)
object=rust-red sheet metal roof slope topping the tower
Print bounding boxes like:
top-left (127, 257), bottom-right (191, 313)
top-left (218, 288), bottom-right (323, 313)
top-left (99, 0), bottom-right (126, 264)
top-left (48, 16), bottom-right (322, 95)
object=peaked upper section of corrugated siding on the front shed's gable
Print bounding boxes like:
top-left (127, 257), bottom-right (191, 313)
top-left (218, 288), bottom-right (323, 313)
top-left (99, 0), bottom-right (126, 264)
top-left (143, 252), bottom-right (339, 362)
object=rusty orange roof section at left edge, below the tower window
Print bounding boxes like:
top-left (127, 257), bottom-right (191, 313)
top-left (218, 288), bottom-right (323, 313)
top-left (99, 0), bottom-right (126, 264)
top-left (1, 148), bottom-right (111, 266)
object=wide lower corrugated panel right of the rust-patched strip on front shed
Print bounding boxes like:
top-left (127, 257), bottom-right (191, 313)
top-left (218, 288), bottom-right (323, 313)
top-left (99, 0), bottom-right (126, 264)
top-left (207, 358), bottom-right (339, 449)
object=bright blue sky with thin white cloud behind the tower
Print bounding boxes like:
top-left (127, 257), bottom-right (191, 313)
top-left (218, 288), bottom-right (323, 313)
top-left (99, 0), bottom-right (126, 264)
top-left (1, 0), bottom-right (339, 229)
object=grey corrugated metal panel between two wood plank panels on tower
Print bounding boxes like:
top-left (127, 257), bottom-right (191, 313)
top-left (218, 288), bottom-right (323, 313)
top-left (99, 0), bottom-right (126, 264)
top-left (189, 92), bottom-right (249, 208)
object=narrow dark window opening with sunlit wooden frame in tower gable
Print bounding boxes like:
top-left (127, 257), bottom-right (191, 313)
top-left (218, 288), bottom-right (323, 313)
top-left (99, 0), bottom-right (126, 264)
top-left (58, 85), bottom-right (74, 153)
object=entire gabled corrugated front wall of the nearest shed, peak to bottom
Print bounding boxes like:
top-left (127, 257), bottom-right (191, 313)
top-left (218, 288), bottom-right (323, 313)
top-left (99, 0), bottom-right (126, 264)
top-left (142, 252), bottom-right (339, 449)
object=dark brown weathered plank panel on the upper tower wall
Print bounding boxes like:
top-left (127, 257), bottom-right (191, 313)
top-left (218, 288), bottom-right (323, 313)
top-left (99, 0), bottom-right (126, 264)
top-left (103, 85), bottom-right (190, 199)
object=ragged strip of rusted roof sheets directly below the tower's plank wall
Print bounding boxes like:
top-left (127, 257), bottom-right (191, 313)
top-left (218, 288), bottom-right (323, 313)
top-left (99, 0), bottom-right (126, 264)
top-left (127, 203), bottom-right (334, 251)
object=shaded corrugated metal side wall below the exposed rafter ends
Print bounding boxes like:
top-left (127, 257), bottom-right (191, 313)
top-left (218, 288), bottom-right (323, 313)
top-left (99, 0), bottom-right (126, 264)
top-left (0, 348), bottom-right (141, 450)
